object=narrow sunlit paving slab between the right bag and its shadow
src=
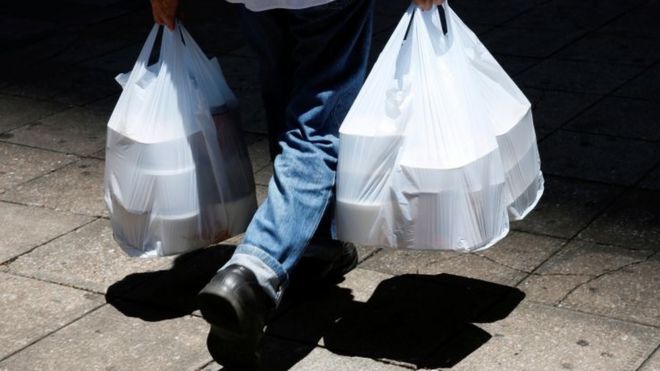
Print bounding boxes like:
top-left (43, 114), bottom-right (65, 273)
top-left (361, 246), bottom-right (526, 285)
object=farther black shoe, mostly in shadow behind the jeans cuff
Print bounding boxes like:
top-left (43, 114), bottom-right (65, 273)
top-left (289, 240), bottom-right (358, 290)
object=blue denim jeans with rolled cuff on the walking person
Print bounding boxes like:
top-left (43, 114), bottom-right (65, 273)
top-left (225, 0), bottom-right (374, 301)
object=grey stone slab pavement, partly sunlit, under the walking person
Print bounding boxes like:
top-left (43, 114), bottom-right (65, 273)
top-left (0, 0), bottom-right (660, 371)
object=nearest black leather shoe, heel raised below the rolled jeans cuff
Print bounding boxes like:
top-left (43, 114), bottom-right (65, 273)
top-left (197, 264), bottom-right (275, 370)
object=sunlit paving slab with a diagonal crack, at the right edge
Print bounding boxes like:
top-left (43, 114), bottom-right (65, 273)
top-left (519, 241), bottom-right (660, 326)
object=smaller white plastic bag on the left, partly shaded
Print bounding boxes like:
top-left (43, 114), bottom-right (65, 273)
top-left (105, 25), bottom-right (256, 257)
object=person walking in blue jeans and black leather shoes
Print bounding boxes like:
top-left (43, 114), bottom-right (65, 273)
top-left (151, 0), bottom-right (442, 369)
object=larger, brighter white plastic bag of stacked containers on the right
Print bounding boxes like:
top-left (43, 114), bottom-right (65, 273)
top-left (336, 2), bottom-right (543, 251)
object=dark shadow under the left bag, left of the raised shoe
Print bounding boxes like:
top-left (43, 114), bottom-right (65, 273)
top-left (106, 245), bottom-right (235, 321)
